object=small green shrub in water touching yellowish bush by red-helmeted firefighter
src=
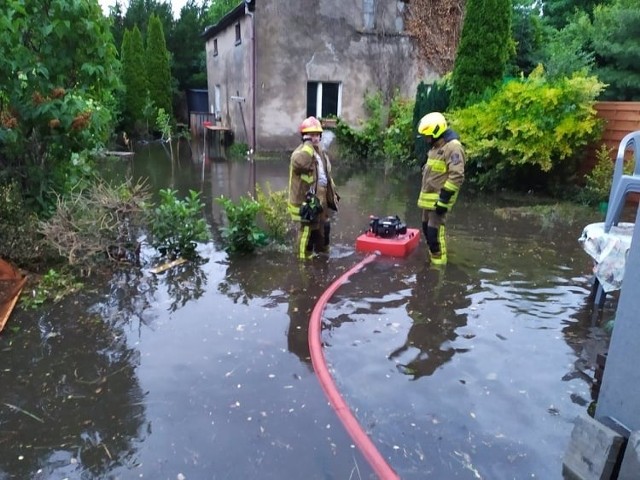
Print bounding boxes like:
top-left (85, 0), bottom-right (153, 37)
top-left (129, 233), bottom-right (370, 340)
top-left (216, 196), bottom-right (266, 254)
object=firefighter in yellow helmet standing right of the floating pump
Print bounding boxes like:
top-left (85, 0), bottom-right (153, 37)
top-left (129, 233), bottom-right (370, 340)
top-left (418, 112), bottom-right (466, 265)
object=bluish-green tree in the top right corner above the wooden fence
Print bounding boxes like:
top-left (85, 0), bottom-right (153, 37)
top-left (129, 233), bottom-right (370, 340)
top-left (591, 0), bottom-right (640, 101)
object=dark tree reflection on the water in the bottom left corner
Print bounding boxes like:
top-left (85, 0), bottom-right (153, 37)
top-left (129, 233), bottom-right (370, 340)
top-left (0, 299), bottom-right (146, 479)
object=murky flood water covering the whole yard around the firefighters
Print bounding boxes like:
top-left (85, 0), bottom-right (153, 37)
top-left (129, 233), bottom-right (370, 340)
top-left (0, 141), bottom-right (615, 480)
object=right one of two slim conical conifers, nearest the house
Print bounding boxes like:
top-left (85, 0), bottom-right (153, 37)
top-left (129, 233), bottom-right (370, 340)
top-left (146, 14), bottom-right (173, 122)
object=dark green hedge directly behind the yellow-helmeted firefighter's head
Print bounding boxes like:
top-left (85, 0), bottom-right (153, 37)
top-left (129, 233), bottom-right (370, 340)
top-left (412, 75), bottom-right (451, 165)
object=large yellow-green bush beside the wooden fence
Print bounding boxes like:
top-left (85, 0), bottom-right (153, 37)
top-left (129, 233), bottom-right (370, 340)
top-left (449, 68), bottom-right (603, 190)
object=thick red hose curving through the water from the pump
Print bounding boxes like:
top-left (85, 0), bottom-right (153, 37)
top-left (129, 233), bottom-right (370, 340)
top-left (309, 254), bottom-right (400, 480)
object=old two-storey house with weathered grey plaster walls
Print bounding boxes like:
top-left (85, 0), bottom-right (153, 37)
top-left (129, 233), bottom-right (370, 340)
top-left (203, 0), bottom-right (436, 151)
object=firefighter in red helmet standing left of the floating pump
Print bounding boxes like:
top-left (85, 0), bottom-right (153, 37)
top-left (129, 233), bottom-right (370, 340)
top-left (288, 117), bottom-right (340, 259)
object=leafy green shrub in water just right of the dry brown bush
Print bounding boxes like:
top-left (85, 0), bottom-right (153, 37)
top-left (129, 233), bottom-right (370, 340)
top-left (147, 188), bottom-right (210, 259)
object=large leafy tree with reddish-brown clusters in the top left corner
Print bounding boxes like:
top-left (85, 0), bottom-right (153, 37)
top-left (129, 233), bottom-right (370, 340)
top-left (0, 0), bottom-right (120, 208)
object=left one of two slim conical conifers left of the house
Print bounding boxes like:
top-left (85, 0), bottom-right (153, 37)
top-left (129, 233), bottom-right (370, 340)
top-left (121, 26), bottom-right (149, 134)
